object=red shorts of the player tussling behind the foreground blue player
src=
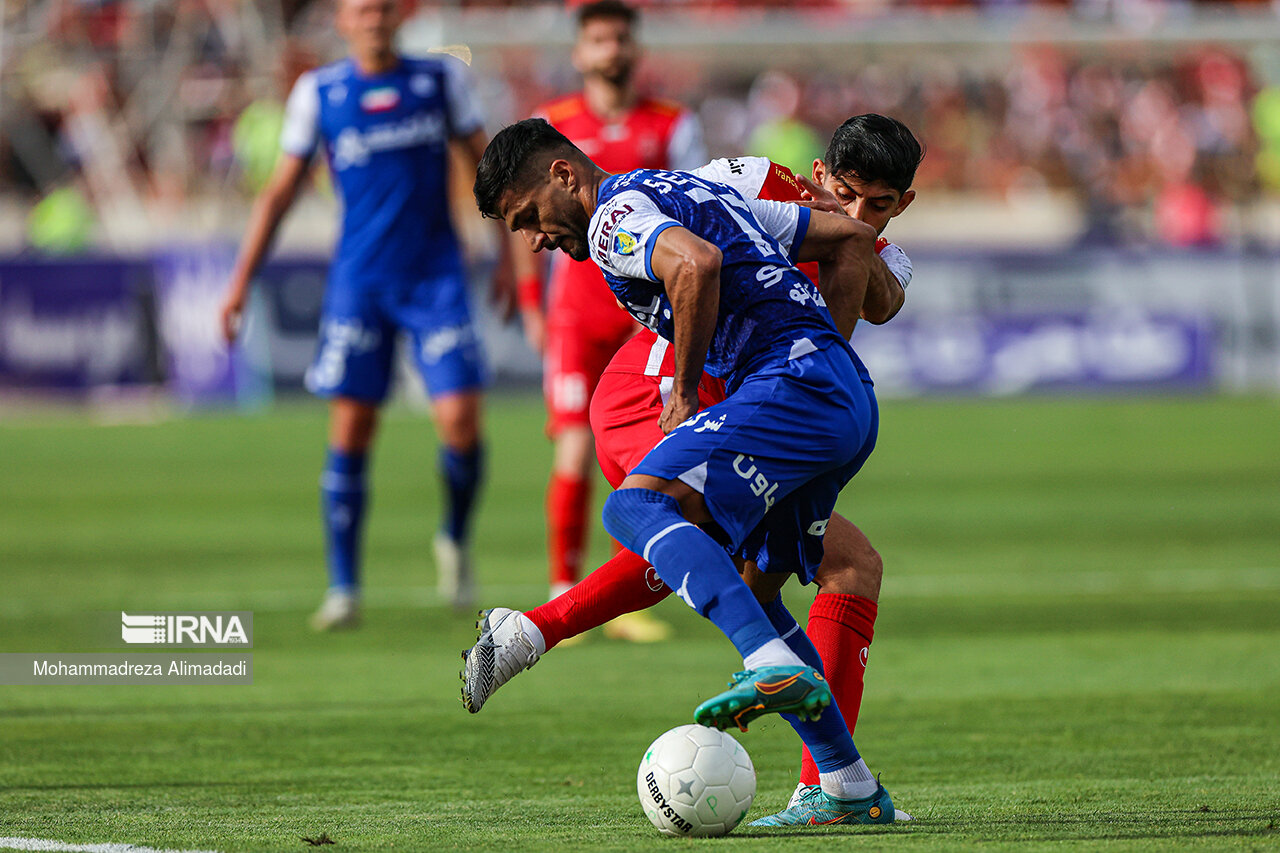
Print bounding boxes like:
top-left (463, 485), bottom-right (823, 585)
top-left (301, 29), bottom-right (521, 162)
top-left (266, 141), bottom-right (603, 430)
top-left (591, 371), bottom-right (724, 488)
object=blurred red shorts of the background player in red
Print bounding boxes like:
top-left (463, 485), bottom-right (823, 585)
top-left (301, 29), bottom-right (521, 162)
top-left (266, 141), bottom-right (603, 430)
top-left (543, 324), bottom-right (635, 438)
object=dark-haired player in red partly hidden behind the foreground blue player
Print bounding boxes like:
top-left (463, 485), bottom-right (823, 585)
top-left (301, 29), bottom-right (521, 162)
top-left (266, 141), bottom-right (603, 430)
top-left (465, 115), bottom-right (922, 802)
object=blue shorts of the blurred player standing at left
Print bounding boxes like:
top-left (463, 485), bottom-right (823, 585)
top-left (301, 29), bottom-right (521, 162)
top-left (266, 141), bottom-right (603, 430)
top-left (306, 264), bottom-right (485, 403)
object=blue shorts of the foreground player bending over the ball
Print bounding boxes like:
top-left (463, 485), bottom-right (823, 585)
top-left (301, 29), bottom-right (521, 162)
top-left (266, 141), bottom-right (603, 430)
top-left (632, 345), bottom-right (879, 583)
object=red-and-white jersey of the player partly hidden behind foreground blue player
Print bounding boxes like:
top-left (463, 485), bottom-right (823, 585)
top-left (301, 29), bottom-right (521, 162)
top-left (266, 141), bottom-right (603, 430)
top-left (605, 158), bottom-right (911, 379)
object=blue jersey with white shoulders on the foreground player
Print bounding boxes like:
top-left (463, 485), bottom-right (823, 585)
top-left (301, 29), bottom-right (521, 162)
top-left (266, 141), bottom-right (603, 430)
top-left (589, 169), bottom-right (847, 391)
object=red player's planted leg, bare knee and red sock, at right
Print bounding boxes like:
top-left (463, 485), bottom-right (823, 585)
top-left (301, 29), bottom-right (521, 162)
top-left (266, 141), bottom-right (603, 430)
top-left (800, 512), bottom-right (883, 785)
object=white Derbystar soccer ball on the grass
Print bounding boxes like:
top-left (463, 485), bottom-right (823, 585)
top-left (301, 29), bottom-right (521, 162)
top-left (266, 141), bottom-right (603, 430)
top-left (636, 725), bottom-right (755, 836)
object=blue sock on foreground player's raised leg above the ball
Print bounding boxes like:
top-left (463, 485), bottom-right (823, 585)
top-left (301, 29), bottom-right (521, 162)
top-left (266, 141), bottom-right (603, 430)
top-left (604, 489), bottom-right (778, 657)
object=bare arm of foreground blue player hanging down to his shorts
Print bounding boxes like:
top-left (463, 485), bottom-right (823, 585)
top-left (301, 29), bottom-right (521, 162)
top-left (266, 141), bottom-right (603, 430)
top-left (649, 225), bottom-right (723, 433)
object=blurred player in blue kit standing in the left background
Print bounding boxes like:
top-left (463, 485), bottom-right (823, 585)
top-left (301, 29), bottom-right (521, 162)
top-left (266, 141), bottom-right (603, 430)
top-left (221, 0), bottom-right (511, 630)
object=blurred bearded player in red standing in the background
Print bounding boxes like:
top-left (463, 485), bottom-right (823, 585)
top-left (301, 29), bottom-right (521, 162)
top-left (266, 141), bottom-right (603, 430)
top-left (518, 0), bottom-right (707, 630)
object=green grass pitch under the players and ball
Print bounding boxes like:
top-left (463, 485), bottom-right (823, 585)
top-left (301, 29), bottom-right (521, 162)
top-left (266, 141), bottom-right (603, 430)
top-left (0, 396), bottom-right (1280, 853)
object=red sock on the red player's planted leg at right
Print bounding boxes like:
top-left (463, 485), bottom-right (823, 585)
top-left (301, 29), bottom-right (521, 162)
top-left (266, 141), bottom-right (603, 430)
top-left (800, 593), bottom-right (876, 785)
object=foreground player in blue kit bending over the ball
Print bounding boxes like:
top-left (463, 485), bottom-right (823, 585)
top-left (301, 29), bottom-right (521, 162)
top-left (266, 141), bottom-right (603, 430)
top-left (475, 119), bottom-right (895, 825)
